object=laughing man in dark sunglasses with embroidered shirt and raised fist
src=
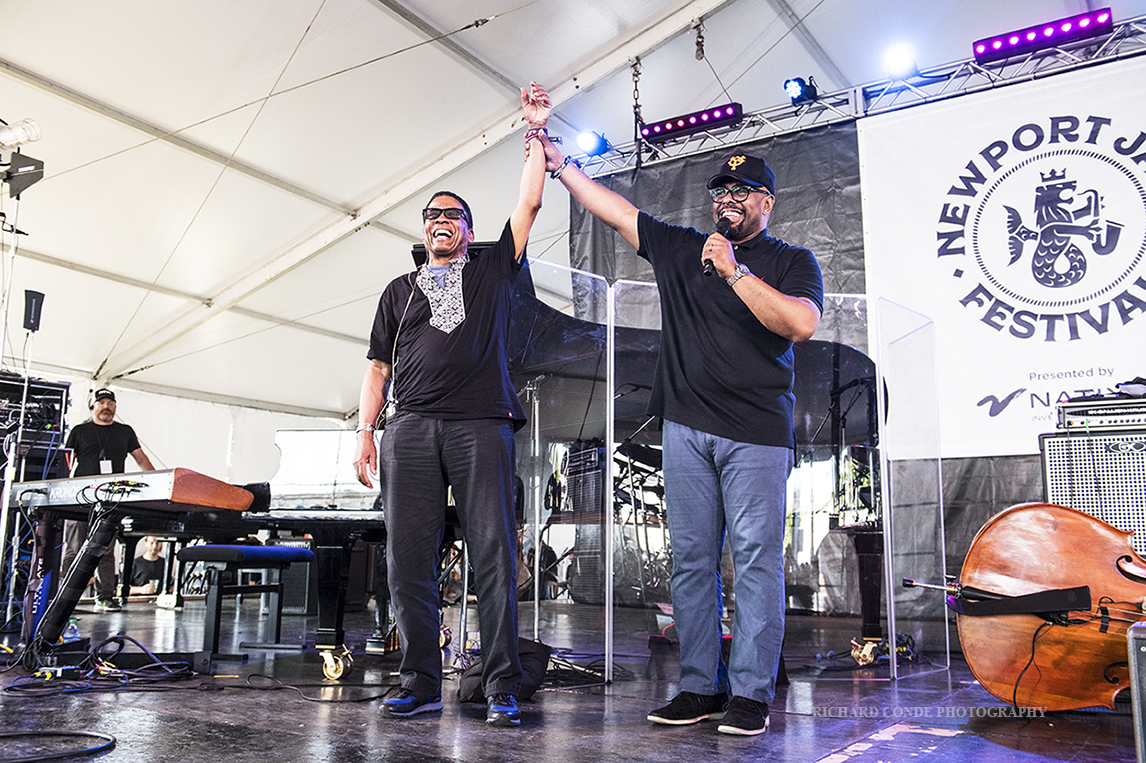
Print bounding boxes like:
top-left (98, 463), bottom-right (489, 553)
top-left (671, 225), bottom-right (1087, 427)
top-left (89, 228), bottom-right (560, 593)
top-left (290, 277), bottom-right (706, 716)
top-left (354, 84), bottom-right (551, 726)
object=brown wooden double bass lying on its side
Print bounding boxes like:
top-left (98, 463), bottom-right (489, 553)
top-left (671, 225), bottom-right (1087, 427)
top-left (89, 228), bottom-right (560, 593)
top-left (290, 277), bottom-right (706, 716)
top-left (948, 503), bottom-right (1146, 710)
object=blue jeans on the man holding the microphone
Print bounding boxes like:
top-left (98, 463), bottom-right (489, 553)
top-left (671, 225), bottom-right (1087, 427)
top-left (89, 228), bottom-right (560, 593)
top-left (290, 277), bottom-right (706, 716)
top-left (662, 420), bottom-right (792, 702)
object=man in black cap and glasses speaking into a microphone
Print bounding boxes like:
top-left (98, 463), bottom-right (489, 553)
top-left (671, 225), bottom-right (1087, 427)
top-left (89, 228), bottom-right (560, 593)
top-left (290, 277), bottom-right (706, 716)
top-left (543, 139), bottom-right (824, 736)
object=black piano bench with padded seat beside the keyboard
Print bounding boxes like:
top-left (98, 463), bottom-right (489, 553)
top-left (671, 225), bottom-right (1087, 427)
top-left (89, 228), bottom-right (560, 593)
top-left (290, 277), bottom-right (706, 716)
top-left (176, 545), bottom-right (314, 674)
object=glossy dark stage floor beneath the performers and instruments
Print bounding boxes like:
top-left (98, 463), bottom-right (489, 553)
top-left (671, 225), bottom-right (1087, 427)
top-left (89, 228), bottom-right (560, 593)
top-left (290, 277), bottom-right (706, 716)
top-left (0, 598), bottom-right (1136, 763)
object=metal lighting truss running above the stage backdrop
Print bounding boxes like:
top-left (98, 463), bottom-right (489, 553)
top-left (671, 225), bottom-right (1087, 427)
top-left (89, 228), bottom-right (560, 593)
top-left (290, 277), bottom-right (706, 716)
top-left (574, 16), bottom-right (1146, 175)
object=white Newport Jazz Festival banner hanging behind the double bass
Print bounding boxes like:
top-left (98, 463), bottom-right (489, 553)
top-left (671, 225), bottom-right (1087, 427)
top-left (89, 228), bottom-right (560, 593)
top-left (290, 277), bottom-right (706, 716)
top-left (858, 57), bottom-right (1146, 457)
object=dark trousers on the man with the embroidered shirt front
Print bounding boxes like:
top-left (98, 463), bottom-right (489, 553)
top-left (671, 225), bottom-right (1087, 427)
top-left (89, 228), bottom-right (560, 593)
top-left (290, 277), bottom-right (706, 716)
top-left (379, 412), bottom-right (521, 697)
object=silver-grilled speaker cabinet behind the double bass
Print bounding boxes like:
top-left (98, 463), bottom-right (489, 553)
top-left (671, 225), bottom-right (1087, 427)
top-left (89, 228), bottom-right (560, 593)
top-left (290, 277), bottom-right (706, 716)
top-left (1038, 430), bottom-right (1146, 556)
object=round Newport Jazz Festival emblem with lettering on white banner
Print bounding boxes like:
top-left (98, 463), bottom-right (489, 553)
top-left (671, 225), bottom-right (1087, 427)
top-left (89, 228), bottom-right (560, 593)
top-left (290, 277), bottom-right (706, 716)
top-left (935, 116), bottom-right (1146, 343)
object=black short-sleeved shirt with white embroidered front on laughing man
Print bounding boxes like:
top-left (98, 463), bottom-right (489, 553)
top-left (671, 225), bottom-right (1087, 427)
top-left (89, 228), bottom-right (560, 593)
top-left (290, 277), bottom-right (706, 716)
top-left (367, 216), bottom-right (525, 428)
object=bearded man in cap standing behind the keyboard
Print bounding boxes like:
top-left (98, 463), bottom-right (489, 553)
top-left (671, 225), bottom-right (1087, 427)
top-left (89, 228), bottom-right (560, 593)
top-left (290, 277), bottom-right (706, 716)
top-left (60, 388), bottom-right (155, 612)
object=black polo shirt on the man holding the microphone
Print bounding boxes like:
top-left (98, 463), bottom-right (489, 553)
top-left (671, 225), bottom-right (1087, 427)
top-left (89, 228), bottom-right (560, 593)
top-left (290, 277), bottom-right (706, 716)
top-left (637, 212), bottom-right (824, 447)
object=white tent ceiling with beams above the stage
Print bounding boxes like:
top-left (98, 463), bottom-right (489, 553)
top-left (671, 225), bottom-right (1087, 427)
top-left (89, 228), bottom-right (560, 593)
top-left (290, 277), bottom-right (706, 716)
top-left (0, 0), bottom-right (1146, 417)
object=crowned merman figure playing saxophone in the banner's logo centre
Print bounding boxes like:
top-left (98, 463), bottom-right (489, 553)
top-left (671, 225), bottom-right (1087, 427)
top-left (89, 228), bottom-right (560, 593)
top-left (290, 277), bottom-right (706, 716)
top-left (1003, 170), bottom-right (1122, 289)
